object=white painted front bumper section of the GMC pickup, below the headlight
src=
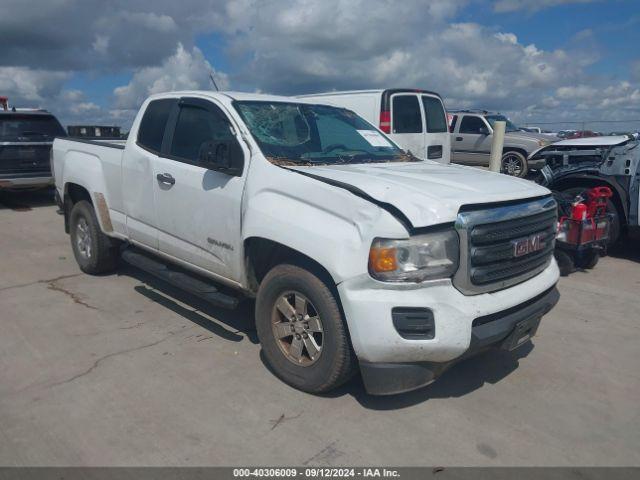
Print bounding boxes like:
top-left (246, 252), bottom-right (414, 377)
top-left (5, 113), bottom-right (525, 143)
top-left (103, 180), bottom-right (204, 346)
top-left (338, 260), bottom-right (560, 394)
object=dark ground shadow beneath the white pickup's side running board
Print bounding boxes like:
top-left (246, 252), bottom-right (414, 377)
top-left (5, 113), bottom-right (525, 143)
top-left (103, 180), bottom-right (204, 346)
top-left (117, 262), bottom-right (258, 344)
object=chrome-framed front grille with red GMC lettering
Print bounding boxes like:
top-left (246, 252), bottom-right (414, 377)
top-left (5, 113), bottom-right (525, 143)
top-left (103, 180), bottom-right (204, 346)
top-left (454, 197), bottom-right (557, 294)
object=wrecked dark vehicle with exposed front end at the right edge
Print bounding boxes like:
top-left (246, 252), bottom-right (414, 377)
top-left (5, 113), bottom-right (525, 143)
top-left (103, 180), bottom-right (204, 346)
top-left (532, 136), bottom-right (640, 245)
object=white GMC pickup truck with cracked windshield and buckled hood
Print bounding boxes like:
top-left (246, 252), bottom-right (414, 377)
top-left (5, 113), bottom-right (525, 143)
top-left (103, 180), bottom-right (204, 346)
top-left (53, 91), bottom-right (558, 394)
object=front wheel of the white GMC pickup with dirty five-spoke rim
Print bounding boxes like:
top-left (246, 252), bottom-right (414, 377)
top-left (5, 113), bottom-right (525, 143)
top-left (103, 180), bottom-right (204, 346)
top-left (256, 264), bottom-right (356, 393)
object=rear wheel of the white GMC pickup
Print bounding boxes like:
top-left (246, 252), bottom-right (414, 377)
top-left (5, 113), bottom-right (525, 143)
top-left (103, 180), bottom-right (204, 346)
top-left (69, 200), bottom-right (118, 275)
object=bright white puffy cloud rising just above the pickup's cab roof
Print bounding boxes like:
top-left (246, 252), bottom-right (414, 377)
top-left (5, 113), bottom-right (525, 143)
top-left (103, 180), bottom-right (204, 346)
top-left (113, 44), bottom-right (229, 110)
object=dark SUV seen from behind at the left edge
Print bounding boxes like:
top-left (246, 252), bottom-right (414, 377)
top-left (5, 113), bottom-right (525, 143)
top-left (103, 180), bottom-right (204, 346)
top-left (0, 101), bottom-right (67, 190)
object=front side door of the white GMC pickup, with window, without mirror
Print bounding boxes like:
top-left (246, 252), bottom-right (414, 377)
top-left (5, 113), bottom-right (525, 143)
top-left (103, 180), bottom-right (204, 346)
top-left (153, 98), bottom-right (249, 281)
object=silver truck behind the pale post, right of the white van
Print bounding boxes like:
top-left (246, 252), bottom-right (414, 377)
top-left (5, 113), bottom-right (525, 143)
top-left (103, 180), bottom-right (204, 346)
top-left (450, 110), bottom-right (553, 177)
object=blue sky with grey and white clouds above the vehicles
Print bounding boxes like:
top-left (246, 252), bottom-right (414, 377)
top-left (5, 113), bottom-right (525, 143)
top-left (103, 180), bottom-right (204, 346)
top-left (0, 0), bottom-right (640, 131)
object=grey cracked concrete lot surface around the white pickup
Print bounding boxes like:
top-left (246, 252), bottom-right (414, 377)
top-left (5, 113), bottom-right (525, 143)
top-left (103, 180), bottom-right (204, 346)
top-left (0, 189), bottom-right (640, 466)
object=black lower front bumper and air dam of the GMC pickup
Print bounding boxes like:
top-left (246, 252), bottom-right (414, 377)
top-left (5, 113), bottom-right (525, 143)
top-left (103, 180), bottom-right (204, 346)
top-left (360, 287), bottom-right (560, 395)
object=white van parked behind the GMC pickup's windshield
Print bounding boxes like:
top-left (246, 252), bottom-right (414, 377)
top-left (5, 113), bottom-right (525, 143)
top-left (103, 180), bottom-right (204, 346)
top-left (298, 88), bottom-right (451, 163)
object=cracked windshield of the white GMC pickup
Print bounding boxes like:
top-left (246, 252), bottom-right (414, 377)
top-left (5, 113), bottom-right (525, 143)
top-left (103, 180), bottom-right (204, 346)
top-left (235, 101), bottom-right (418, 165)
